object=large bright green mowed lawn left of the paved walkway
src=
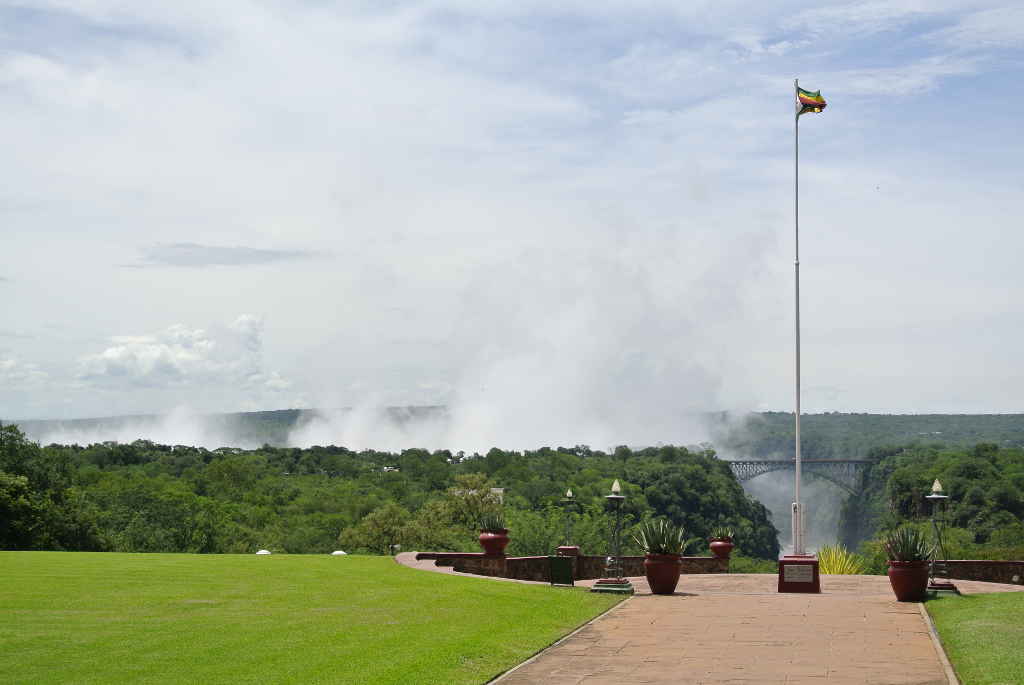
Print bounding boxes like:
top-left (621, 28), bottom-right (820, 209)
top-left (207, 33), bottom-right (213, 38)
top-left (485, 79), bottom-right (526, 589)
top-left (0, 552), bottom-right (617, 684)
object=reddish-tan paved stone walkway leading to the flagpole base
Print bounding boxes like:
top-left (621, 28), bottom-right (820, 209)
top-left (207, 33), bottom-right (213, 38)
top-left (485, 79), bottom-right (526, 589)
top-left (398, 555), bottom-right (1024, 685)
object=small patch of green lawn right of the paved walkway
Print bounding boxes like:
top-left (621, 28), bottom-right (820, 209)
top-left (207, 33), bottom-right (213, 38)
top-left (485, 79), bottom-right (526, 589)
top-left (926, 592), bottom-right (1024, 685)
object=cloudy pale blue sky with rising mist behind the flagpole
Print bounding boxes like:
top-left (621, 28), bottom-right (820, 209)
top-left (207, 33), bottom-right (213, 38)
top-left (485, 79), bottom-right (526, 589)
top-left (0, 0), bottom-right (1024, 444)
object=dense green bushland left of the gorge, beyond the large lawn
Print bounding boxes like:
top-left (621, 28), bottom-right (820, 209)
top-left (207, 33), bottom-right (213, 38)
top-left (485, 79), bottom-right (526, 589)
top-left (0, 426), bottom-right (778, 558)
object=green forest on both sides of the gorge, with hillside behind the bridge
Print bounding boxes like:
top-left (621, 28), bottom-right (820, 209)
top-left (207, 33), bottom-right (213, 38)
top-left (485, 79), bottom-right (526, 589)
top-left (8, 414), bottom-right (1024, 571)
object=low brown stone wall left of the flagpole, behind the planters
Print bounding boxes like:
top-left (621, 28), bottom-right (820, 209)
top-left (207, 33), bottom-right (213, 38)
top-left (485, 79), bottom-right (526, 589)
top-left (416, 552), bottom-right (729, 583)
